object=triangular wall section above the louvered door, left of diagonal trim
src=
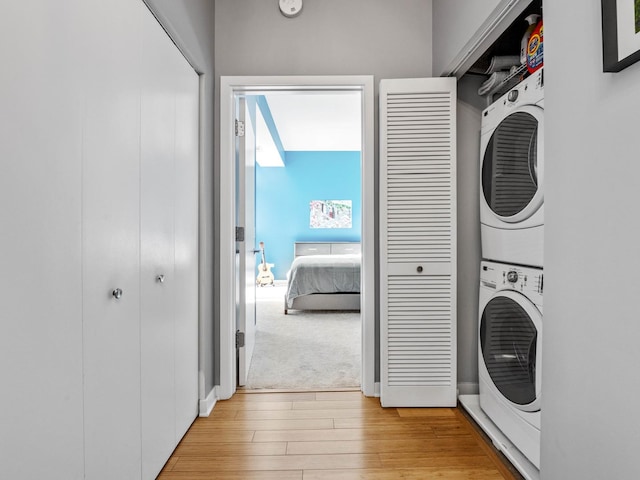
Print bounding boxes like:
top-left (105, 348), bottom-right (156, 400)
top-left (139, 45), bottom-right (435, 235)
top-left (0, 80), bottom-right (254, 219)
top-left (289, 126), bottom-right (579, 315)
top-left (433, 0), bottom-right (501, 75)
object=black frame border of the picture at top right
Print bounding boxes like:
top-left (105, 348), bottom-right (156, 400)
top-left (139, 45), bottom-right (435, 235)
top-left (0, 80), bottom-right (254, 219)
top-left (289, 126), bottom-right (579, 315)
top-left (602, 0), bottom-right (640, 72)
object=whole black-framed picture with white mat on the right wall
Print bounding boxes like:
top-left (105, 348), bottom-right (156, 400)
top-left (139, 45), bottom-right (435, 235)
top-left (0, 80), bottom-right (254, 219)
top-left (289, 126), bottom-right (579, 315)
top-left (602, 0), bottom-right (640, 72)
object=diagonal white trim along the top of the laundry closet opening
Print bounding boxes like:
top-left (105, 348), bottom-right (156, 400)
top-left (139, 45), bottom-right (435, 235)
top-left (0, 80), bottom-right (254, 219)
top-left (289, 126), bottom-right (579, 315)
top-left (440, 0), bottom-right (531, 78)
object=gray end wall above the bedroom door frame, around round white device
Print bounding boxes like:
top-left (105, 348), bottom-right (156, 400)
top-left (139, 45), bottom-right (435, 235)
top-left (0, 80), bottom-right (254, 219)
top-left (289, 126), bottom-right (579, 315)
top-left (215, 0), bottom-right (432, 382)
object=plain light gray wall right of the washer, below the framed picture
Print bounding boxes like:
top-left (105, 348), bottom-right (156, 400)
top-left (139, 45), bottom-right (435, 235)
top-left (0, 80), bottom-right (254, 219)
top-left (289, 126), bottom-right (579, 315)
top-left (541, 0), bottom-right (640, 480)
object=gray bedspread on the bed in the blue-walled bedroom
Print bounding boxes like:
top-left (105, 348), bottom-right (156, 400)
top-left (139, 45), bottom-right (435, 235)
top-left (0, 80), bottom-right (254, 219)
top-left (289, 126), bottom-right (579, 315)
top-left (287, 254), bottom-right (361, 308)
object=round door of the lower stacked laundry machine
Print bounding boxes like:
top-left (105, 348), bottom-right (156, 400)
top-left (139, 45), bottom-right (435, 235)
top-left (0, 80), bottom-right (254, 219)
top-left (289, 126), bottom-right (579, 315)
top-left (479, 290), bottom-right (542, 412)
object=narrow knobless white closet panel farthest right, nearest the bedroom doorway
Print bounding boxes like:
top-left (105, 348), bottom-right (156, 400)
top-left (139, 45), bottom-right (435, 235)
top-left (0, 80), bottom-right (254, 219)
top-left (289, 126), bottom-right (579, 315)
top-left (173, 50), bottom-right (199, 438)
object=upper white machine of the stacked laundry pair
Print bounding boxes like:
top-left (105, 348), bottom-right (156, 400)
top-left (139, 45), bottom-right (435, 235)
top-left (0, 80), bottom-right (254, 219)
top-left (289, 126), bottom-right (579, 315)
top-left (480, 69), bottom-right (544, 267)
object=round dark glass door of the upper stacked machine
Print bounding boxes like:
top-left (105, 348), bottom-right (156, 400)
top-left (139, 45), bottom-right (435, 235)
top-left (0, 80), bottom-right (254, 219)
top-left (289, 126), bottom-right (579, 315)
top-left (482, 112), bottom-right (538, 217)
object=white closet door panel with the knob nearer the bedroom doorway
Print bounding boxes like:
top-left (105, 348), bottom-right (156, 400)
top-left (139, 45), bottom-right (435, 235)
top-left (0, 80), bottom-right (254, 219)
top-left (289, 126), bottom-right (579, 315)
top-left (140, 13), bottom-right (177, 479)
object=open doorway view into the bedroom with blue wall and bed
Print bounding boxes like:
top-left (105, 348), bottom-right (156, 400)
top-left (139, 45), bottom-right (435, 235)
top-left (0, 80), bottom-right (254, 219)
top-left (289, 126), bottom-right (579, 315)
top-left (245, 90), bottom-right (362, 390)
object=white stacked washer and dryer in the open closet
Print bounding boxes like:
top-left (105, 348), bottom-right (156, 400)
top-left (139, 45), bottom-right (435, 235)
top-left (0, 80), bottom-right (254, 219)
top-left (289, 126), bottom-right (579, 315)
top-left (478, 69), bottom-right (544, 468)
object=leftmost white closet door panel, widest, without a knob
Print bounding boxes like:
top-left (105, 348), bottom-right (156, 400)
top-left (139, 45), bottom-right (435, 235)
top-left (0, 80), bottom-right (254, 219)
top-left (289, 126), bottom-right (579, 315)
top-left (0, 0), bottom-right (84, 479)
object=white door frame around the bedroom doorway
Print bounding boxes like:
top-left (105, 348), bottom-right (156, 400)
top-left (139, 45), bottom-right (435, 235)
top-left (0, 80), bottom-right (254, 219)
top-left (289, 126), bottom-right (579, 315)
top-left (217, 75), bottom-right (376, 400)
